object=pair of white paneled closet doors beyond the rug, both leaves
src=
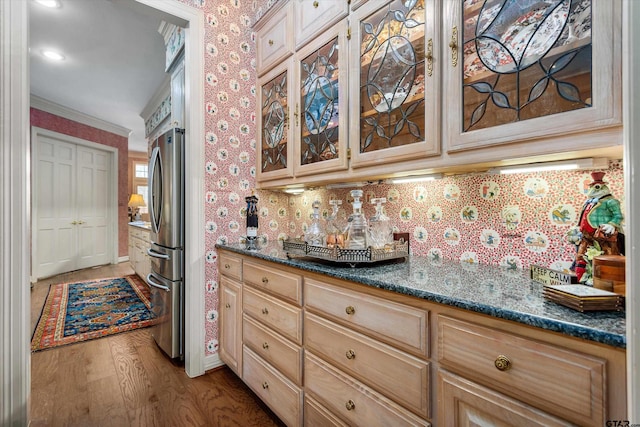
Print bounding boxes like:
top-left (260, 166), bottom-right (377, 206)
top-left (31, 127), bottom-right (118, 281)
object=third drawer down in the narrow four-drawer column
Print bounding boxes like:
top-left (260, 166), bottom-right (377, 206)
top-left (242, 315), bottom-right (302, 385)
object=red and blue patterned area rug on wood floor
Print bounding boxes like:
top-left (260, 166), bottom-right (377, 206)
top-left (31, 275), bottom-right (157, 351)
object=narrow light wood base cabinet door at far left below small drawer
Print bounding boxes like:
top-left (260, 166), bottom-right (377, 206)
top-left (219, 276), bottom-right (242, 375)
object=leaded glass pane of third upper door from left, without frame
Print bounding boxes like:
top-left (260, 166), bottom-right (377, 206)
top-left (360, 0), bottom-right (425, 153)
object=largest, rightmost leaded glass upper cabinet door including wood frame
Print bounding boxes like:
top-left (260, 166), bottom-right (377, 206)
top-left (441, 0), bottom-right (621, 155)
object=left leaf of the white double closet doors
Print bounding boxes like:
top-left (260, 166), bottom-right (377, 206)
top-left (33, 136), bottom-right (77, 277)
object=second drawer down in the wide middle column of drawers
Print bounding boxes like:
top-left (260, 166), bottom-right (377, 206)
top-left (304, 313), bottom-right (429, 418)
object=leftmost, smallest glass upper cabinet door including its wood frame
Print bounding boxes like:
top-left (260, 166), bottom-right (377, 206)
top-left (256, 58), bottom-right (295, 181)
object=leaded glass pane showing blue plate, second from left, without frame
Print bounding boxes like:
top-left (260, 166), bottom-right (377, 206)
top-left (300, 37), bottom-right (339, 165)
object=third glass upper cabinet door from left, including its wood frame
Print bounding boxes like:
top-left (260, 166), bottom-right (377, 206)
top-left (349, 0), bottom-right (440, 173)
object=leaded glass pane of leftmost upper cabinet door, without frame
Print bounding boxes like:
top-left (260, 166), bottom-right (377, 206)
top-left (261, 71), bottom-right (289, 172)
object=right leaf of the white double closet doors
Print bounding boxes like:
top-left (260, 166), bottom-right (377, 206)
top-left (76, 146), bottom-right (111, 268)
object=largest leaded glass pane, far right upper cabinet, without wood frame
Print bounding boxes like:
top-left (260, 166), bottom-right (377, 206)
top-left (461, 0), bottom-right (592, 132)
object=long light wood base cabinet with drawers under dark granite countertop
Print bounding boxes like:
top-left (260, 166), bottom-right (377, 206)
top-left (218, 250), bottom-right (627, 427)
